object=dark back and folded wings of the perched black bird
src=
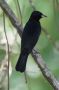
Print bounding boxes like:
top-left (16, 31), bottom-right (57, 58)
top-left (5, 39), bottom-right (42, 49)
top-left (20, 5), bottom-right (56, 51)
top-left (21, 23), bottom-right (40, 52)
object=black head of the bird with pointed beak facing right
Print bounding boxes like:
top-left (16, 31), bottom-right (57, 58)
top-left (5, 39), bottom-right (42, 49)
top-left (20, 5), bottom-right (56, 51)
top-left (30, 11), bottom-right (47, 21)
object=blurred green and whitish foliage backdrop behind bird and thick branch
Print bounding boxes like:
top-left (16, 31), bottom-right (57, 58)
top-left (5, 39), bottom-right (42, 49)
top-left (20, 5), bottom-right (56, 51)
top-left (0, 0), bottom-right (59, 90)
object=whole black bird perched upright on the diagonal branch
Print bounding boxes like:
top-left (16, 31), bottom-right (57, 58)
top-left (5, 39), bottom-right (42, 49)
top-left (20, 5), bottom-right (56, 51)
top-left (16, 11), bottom-right (46, 72)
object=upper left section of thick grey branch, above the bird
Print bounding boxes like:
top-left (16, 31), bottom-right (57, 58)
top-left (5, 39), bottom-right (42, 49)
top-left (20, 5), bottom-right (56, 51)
top-left (0, 0), bottom-right (23, 35)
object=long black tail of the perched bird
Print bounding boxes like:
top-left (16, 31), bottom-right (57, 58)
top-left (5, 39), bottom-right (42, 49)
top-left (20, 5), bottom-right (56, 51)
top-left (16, 53), bottom-right (28, 72)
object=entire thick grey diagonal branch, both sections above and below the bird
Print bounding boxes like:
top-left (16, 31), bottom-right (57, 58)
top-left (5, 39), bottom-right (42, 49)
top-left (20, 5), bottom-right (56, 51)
top-left (0, 0), bottom-right (59, 90)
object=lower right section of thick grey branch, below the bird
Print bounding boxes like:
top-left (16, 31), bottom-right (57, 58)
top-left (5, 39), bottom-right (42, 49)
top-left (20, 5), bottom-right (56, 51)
top-left (32, 49), bottom-right (59, 90)
